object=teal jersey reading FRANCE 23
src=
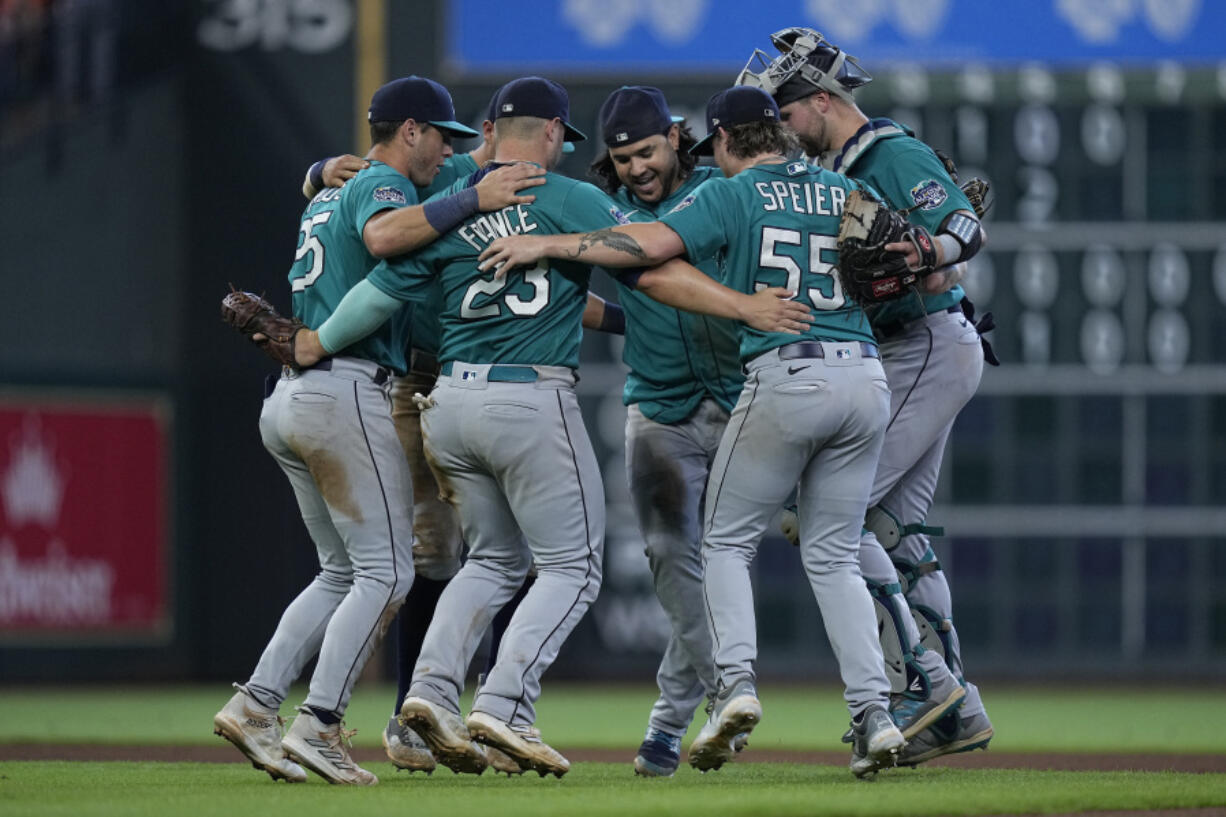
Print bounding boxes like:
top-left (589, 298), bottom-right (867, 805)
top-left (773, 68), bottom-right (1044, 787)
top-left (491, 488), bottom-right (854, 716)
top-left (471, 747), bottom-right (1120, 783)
top-left (370, 164), bottom-right (625, 368)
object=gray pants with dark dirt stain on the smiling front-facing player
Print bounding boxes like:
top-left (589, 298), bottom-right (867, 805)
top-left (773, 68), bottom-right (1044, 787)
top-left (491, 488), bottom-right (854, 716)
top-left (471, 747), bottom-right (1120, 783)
top-left (625, 399), bottom-right (728, 736)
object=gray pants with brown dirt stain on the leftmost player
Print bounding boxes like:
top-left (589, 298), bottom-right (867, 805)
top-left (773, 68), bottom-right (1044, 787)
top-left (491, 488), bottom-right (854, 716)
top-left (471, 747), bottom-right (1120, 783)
top-left (246, 357), bottom-right (413, 715)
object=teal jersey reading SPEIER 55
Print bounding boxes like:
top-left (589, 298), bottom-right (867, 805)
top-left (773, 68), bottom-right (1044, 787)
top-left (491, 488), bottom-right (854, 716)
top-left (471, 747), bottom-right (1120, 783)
top-left (660, 162), bottom-right (873, 361)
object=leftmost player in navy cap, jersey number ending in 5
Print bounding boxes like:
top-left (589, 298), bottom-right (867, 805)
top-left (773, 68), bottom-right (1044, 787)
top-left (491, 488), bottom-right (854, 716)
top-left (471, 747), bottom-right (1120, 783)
top-left (213, 76), bottom-right (477, 785)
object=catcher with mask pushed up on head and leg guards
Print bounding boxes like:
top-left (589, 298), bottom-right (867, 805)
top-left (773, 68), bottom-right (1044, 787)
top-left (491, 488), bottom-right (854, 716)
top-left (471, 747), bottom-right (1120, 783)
top-left (738, 28), bottom-right (994, 765)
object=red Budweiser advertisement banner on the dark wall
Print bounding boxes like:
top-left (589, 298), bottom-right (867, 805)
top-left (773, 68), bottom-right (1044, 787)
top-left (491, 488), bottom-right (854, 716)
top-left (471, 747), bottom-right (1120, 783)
top-left (0, 395), bottom-right (172, 646)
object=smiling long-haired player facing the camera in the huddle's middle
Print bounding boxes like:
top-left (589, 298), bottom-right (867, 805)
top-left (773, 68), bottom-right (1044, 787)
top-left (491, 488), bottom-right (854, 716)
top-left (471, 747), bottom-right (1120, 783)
top-left (592, 86), bottom-right (744, 777)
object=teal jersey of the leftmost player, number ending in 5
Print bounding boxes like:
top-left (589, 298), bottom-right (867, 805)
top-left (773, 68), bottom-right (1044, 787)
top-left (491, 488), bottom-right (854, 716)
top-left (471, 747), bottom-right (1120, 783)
top-left (289, 156), bottom-right (417, 373)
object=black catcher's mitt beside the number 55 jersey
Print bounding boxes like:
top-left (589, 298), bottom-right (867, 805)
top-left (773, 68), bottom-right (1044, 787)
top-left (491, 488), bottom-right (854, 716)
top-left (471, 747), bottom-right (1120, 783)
top-left (837, 190), bottom-right (937, 305)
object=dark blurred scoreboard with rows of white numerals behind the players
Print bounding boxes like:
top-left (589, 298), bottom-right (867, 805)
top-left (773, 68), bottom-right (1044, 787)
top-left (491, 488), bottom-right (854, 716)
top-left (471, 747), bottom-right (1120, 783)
top-left (568, 64), bottom-right (1226, 675)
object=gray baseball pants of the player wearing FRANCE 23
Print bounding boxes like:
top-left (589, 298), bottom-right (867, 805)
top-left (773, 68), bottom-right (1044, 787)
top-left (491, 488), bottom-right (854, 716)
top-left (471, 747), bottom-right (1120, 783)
top-left (409, 363), bottom-right (604, 725)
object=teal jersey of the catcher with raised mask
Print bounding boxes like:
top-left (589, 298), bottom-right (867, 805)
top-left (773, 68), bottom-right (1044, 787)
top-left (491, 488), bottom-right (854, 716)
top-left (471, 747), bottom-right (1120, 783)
top-left (830, 119), bottom-right (975, 325)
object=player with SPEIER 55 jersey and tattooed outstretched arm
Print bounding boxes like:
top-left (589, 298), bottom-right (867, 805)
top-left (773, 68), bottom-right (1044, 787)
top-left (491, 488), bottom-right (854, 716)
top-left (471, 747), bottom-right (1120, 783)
top-left (483, 87), bottom-right (921, 777)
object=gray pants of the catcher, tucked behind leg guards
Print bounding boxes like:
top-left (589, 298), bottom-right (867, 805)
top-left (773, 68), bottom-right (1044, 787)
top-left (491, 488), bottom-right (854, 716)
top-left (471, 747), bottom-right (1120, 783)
top-left (861, 305), bottom-right (983, 715)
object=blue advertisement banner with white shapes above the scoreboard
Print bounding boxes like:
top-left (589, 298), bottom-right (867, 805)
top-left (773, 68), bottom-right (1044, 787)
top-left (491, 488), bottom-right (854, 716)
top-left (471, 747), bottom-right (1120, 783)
top-left (446, 0), bottom-right (1226, 73)
